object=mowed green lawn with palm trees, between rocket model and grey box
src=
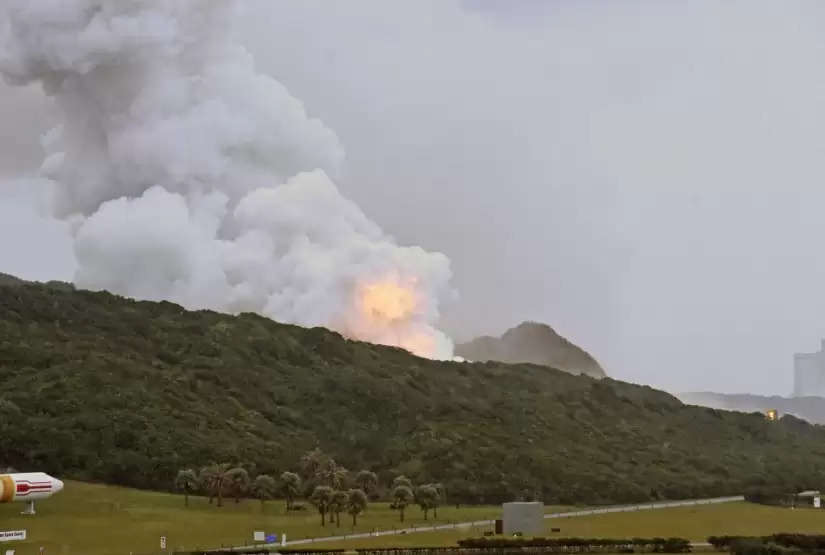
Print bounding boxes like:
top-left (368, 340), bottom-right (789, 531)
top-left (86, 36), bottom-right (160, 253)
top-left (0, 482), bottom-right (528, 555)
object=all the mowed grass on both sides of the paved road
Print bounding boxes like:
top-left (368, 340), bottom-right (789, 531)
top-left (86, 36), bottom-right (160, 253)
top-left (8, 482), bottom-right (825, 555)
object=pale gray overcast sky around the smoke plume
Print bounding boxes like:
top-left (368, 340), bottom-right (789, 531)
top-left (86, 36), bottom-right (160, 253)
top-left (0, 0), bottom-right (825, 394)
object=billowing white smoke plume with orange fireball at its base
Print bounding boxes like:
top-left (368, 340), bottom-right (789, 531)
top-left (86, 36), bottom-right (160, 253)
top-left (0, 0), bottom-right (452, 358)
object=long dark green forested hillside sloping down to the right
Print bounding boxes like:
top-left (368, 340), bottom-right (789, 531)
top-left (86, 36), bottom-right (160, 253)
top-left (0, 278), bottom-right (825, 504)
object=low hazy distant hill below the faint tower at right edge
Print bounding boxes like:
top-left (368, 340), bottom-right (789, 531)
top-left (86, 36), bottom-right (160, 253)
top-left (679, 392), bottom-right (825, 424)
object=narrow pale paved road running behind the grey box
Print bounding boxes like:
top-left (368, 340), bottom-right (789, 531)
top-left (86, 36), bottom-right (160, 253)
top-left (229, 495), bottom-right (745, 547)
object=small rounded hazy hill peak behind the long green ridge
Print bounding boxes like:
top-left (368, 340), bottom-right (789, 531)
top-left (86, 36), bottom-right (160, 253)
top-left (455, 322), bottom-right (605, 378)
